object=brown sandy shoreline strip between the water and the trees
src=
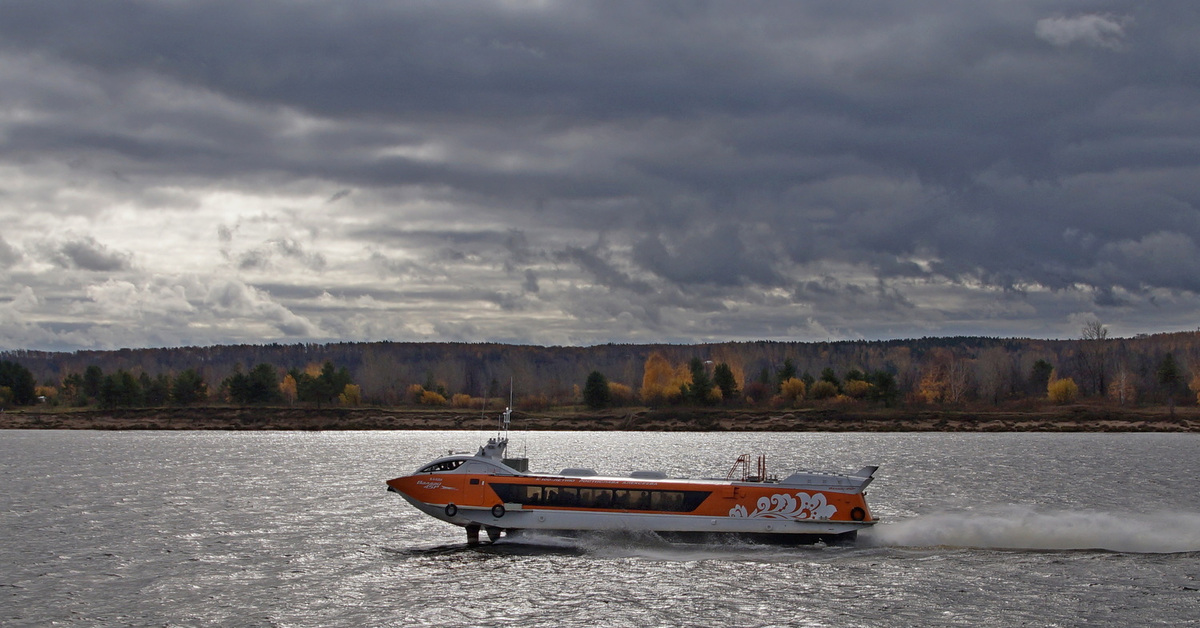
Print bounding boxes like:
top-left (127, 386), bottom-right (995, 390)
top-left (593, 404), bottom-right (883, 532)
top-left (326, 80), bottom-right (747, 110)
top-left (0, 406), bottom-right (1200, 433)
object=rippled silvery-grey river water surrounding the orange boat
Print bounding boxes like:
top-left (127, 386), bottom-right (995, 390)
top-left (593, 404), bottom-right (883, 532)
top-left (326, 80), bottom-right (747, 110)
top-left (0, 431), bottom-right (1200, 627)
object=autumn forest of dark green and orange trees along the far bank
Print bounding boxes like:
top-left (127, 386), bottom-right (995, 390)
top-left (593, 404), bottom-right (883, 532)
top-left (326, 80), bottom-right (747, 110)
top-left (0, 323), bottom-right (1200, 409)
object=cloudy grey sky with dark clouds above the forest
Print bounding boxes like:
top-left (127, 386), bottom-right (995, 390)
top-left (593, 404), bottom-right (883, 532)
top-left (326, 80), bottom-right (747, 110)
top-left (0, 0), bottom-right (1200, 351)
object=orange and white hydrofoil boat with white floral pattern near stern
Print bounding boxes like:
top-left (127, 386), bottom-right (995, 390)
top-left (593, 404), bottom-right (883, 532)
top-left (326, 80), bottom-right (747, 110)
top-left (388, 409), bottom-right (877, 544)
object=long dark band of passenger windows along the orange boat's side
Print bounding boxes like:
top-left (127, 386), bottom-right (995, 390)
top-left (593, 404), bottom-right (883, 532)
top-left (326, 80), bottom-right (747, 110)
top-left (491, 483), bottom-right (712, 513)
